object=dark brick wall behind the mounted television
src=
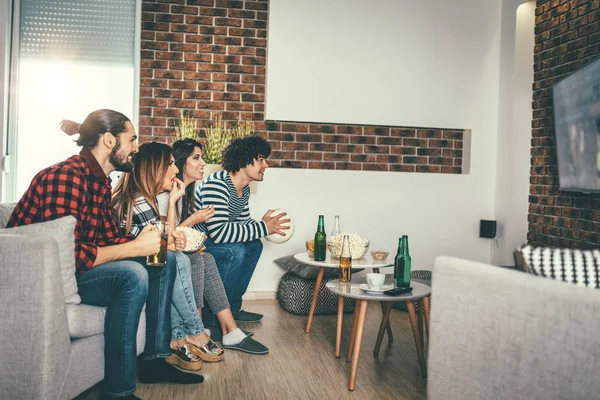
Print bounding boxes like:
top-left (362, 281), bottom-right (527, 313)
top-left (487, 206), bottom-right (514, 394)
top-left (527, 0), bottom-right (600, 248)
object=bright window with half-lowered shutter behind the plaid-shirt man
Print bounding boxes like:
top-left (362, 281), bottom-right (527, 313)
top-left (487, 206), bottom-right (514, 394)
top-left (3, 0), bottom-right (140, 201)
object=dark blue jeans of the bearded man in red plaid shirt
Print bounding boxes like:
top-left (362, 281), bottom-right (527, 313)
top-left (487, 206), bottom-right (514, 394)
top-left (76, 253), bottom-right (176, 397)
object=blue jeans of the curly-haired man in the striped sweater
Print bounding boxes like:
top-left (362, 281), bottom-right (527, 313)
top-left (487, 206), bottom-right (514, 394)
top-left (202, 239), bottom-right (263, 325)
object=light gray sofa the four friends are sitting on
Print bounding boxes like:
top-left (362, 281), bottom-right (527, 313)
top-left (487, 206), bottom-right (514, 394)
top-left (0, 204), bottom-right (146, 400)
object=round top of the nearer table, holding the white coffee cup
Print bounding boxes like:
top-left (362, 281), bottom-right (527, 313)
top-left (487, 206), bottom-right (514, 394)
top-left (325, 276), bottom-right (431, 301)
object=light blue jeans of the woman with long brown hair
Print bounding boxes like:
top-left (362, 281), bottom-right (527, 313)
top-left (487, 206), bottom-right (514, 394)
top-left (171, 251), bottom-right (204, 339)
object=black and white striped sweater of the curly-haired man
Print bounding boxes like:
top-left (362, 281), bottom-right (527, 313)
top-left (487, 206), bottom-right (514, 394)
top-left (194, 171), bottom-right (268, 243)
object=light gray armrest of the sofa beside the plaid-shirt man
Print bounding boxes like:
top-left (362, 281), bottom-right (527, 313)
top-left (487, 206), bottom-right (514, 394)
top-left (0, 235), bottom-right (70, 399)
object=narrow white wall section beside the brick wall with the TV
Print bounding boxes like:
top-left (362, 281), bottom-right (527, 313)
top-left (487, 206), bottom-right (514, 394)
top-left (492, 0), bottom-right (535, 265)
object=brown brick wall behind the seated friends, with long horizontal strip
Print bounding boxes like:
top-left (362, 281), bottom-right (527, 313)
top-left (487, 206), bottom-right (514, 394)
top-left (139, 0), bottom-right (463, 174)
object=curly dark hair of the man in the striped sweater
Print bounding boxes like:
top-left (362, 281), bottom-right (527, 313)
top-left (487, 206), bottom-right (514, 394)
top-left (222, 136), bottom-right (271, 172)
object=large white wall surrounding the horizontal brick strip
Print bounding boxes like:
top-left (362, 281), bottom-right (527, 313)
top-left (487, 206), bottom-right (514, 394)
top-left (249, 0), bottom-right (502, 291)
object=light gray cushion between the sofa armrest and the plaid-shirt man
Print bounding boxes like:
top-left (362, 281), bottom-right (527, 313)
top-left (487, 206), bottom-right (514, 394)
top-left (0, 215), bottom-right (81, 304)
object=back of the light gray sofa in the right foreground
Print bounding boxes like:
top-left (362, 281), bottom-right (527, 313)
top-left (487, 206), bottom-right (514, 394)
top-left (427, 257), bottom-right (600, 400)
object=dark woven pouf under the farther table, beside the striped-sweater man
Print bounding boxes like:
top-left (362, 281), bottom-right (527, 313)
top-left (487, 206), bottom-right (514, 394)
top-left (277, 272), bottom-right (355, 315)
